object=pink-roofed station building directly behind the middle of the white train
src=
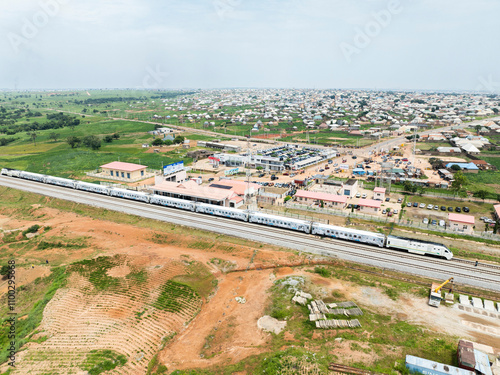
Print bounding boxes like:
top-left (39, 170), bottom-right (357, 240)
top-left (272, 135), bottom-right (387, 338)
top-left (152, 181), bottom-right (243, 207)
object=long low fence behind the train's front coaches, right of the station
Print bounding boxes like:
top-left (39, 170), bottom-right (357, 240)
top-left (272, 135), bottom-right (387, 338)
top-left (286, 202), bottom-right (500, 241)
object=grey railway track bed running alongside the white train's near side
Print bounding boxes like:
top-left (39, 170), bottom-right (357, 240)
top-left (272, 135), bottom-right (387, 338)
top-left (0, 176), bottom-right (500, 292)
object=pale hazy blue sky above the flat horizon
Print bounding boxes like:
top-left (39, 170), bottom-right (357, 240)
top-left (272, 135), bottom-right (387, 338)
top-left (0, 0), bottom-right (500, 91)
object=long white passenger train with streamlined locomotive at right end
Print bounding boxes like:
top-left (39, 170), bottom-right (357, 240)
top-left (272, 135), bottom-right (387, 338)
top-left (0, 168), bottom-right (453, 260)
